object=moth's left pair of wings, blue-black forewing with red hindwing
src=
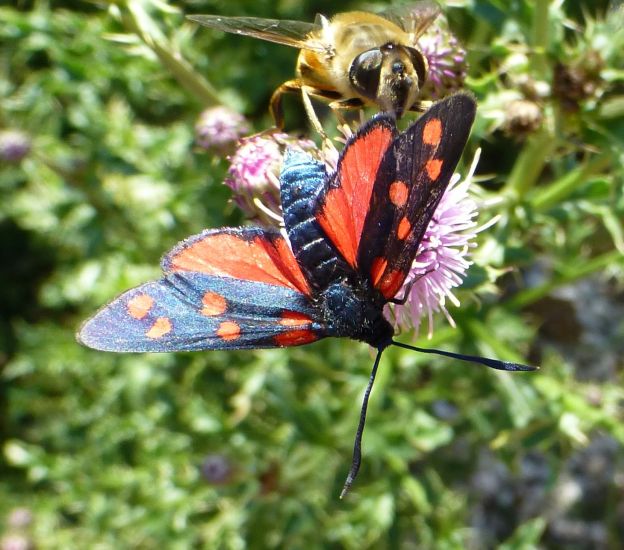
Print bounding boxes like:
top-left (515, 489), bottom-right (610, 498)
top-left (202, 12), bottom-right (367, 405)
top-left (78, 228), bottom-right (326, 352)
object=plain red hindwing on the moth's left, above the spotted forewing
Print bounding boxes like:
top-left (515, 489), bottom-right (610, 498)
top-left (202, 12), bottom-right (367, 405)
top-left (169, 233), bottom-right (310, 295)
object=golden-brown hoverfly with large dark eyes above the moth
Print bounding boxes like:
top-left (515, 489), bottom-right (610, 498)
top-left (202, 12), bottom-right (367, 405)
top-left (188, 1), bottom-right (440, 134)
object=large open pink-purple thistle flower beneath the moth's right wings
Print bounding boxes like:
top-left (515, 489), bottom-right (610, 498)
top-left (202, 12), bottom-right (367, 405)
top-left (386, 153), bottom-right (494, 337)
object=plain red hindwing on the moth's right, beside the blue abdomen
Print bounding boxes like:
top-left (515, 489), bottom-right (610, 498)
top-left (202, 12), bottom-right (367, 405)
top-left (317, 125), bottom-right (393, 267)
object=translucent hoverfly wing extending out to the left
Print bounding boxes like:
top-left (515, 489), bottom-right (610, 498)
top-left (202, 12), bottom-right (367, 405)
top-left (187, 15), bottom-right (324, 51)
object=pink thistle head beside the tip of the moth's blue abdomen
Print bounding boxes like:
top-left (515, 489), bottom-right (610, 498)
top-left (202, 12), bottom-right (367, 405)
top-left (225, 132), bottom-right (316, 225)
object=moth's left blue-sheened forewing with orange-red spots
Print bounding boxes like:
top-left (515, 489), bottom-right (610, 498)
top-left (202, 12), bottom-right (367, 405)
top-left (78, 272), bottom-right (325, 352)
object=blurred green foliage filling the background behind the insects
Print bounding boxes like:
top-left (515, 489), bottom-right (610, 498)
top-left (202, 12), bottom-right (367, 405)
top-left (0, 0), bottom-right (624, 549)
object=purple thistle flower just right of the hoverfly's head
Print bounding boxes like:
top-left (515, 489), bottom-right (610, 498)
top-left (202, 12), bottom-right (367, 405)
top-left (418, 24), bottom-right (467, 99)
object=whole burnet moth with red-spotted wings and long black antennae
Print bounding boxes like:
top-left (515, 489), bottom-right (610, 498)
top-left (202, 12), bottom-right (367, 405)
top-left (77, 93), bottom-right (534, 497)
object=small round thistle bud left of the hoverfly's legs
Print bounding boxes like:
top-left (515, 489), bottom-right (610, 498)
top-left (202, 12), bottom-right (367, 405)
top-left (195, 106), bottom-right (250, 152)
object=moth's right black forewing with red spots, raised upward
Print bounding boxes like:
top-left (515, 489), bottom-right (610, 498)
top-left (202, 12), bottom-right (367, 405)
top-left (357, 94), bottom-right (476, 300)
